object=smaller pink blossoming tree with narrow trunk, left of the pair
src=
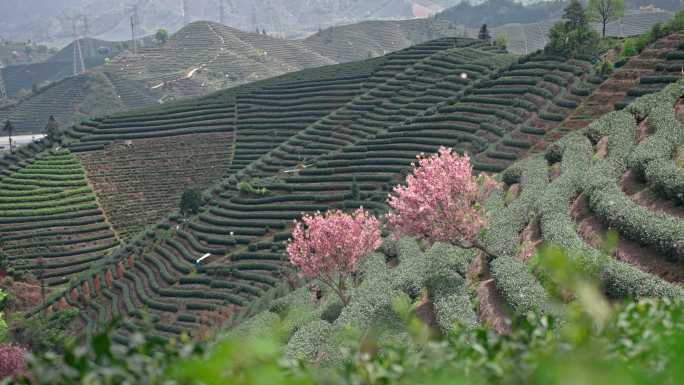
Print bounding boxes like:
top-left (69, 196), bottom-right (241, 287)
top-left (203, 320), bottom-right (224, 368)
top-left (286, 209), bottom-right (382, 305)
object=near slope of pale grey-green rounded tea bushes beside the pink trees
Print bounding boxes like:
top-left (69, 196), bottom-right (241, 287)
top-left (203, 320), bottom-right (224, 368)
top-left (229, 81), bottom-right (684, 354)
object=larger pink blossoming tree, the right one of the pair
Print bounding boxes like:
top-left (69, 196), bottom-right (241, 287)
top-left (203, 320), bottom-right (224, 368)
top-left (387, 147), bottom-right (496, 246)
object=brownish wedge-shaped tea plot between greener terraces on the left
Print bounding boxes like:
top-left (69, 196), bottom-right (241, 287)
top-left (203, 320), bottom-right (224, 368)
top-left (78, 132), bottom-right (233, 238)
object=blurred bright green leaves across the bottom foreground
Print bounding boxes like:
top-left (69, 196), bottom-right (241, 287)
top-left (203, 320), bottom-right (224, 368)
top-left (5, 292), bottom-right (684, 385)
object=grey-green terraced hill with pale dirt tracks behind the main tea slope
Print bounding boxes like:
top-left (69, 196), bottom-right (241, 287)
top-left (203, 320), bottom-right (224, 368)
top-left (0, 19), bottom-right (463, 132)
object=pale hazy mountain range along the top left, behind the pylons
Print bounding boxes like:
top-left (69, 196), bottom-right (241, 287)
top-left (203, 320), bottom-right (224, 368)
top-left (0, 0), bottom-right (459, 44)
